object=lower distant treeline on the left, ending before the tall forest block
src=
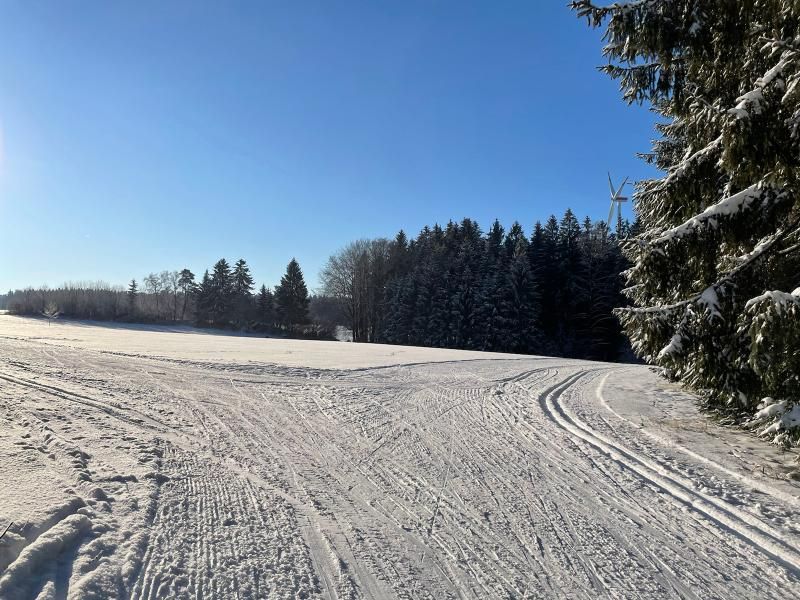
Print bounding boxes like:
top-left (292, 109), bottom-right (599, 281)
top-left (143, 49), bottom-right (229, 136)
top-left (0, 258), bottom-right (341, 338)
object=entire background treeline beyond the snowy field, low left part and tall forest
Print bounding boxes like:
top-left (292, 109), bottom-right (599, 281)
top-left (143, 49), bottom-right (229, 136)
top-left (0, 210), bottom-right (634, 361)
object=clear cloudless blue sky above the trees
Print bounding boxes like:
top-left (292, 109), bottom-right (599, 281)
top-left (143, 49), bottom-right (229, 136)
top-left (0, 0), bottom-right (653, 290)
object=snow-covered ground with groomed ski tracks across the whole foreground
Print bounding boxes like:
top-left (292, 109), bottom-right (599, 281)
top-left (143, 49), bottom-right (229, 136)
top-left (0, 315), bottom-right (800, 600)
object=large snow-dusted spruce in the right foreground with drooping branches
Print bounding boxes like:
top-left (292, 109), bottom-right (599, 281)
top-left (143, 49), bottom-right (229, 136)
top-left (572, 0), bottom-right (800, 443)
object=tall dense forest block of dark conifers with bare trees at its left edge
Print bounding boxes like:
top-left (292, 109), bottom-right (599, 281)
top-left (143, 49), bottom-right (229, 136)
top-left (321, 210), bottom-right (633, 361)
